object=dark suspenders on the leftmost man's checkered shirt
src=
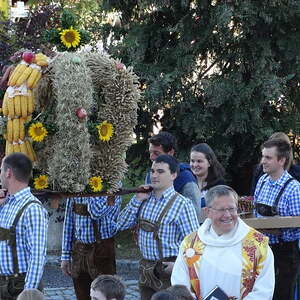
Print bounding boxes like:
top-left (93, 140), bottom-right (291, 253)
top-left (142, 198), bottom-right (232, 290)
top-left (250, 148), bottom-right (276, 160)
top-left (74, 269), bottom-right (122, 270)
top-left (0, 200), bottom-right (41, 274)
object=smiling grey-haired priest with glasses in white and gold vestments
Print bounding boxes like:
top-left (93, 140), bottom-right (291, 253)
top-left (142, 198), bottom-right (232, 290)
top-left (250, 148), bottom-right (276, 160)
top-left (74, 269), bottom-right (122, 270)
top-left (171, 185), bottom-right (275, 300)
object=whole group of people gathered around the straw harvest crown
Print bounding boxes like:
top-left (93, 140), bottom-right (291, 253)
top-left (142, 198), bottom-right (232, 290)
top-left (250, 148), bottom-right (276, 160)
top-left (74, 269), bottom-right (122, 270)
top-left (0, 132), bottom-right (300, 300)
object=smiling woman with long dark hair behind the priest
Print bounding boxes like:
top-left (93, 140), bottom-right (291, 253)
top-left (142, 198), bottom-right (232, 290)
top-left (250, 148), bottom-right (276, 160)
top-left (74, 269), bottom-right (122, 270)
top-left (190, 143), bottom-right (225, 223)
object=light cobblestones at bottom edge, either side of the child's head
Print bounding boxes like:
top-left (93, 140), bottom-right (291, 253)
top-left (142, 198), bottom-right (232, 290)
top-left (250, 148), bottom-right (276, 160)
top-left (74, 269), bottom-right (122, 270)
top-left (44, 280), bottom-right (139, 300)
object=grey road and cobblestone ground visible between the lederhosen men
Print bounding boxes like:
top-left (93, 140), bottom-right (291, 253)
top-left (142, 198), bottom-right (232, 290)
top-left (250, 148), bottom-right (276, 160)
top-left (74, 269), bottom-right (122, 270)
top-left (43, 256), bottom-right (140, 300)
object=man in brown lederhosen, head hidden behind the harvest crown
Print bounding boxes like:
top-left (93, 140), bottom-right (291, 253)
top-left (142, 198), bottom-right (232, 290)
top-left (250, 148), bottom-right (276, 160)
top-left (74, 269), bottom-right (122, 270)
top-left (61, 193), bottom-right (121, 300)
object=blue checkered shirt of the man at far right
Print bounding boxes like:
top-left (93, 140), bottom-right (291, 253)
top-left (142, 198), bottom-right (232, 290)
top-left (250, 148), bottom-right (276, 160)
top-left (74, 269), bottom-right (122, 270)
top-left (254, 171), bottom-right (300, 244)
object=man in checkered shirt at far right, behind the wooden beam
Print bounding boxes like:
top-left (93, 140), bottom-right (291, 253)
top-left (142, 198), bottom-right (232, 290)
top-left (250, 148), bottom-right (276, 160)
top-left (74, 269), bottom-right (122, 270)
top-left (254, 139), bottom-right (300, 300)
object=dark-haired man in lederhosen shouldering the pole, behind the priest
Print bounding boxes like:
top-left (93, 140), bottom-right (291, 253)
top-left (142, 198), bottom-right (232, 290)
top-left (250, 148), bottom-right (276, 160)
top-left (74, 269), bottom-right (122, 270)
top-left (117, 155), bottom-right (199, 300)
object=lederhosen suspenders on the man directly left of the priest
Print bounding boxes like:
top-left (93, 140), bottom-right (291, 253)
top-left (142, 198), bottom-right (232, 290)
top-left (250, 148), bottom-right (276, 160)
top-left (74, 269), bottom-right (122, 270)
top-left (137, 192), bottom-right (179, 259)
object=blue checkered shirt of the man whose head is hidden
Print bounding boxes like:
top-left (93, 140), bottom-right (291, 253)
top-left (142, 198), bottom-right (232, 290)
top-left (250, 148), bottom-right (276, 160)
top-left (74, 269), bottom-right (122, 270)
top-left (61, 196), bottom-right (122, 260)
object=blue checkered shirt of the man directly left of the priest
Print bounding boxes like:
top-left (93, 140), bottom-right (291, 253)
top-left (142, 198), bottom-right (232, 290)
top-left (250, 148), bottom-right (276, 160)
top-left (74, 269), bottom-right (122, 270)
top-left (116, 186), bottom-right (199, 260)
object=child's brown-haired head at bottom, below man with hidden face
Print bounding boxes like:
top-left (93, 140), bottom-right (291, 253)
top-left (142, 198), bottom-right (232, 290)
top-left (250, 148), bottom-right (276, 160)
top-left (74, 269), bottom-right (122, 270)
top-left (91, 275), bottom-right (125, 300)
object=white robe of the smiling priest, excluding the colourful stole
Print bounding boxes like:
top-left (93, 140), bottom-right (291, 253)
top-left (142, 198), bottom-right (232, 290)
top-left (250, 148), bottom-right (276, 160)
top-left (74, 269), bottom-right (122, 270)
top-left (171, 219), bottom-right (275, 300)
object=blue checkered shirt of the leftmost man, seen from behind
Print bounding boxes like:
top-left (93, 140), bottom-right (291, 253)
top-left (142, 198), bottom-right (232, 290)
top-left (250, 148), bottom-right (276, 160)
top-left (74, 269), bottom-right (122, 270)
top-left (0, 187), bottom-right (48, 289)
